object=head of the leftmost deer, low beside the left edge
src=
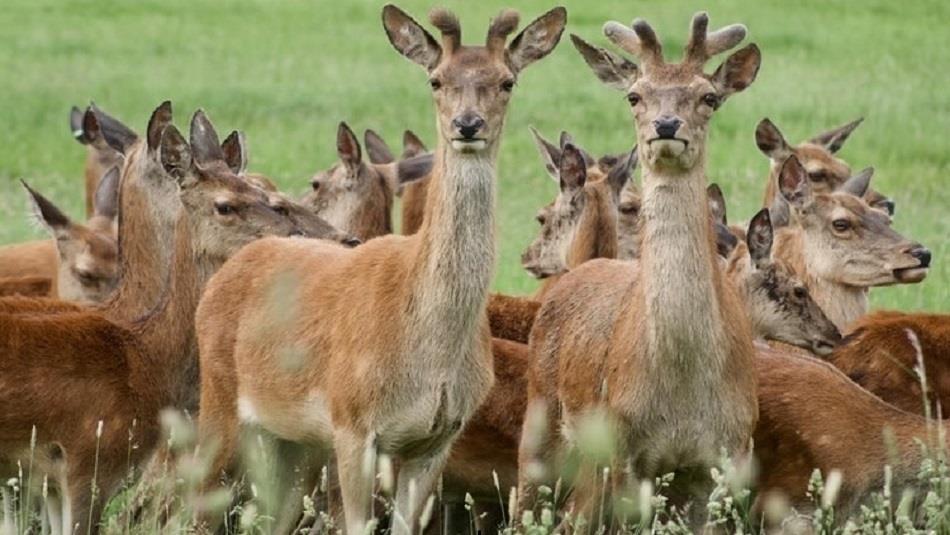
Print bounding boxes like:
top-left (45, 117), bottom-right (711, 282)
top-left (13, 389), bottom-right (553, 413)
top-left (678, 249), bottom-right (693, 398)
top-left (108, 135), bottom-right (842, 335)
top-left (23, 172), bottom-right (119, 303)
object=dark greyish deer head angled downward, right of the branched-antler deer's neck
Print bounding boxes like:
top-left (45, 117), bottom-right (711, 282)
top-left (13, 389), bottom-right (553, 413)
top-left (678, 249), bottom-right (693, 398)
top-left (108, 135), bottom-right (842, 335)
top-left (726, 208), bottom-right (841, 355)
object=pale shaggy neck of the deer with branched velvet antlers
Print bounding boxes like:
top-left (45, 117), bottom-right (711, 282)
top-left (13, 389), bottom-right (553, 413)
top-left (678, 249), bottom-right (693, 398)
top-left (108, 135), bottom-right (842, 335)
top-left (638, 159), bottom-right (741, 371)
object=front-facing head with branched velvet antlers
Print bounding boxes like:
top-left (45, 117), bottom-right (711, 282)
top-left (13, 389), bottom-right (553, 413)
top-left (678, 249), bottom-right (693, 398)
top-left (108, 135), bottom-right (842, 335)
top-left (571, 13), bottom-right (761, 172)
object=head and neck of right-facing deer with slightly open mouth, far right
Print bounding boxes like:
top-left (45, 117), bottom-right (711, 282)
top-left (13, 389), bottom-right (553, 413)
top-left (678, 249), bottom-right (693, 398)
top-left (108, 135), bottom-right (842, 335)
top-left (773, 155), bottom-right (931, 331)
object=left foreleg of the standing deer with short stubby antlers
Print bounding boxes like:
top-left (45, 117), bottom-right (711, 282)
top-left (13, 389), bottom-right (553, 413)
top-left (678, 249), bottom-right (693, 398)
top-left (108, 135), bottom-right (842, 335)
top-left (333, 430), bottom-right (376, 535)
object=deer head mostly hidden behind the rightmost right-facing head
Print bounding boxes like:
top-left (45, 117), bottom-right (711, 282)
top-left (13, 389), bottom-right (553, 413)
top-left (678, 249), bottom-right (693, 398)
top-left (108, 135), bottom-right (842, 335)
top-left (755, 118), bottom-right (894, 215)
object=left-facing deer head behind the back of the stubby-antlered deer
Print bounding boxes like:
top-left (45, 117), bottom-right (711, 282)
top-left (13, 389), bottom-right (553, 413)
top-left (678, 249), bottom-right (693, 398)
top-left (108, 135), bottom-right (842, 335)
top-left (301, 122), bottom-right (432, 241)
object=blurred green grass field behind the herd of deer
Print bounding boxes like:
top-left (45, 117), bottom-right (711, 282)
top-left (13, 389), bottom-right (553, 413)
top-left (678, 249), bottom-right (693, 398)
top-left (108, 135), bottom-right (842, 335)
top-left (0, 0), bottom-right (950, 311)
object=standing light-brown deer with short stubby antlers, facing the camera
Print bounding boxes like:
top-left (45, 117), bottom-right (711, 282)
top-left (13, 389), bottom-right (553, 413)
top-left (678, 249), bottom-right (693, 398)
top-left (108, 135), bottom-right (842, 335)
top-left (197, 4), bottom-right (567, 534)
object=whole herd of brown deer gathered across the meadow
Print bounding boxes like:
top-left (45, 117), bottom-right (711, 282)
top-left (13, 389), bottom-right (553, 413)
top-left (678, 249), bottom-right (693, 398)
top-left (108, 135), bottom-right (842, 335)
top-left (0, 5), bottom-right (950, 533)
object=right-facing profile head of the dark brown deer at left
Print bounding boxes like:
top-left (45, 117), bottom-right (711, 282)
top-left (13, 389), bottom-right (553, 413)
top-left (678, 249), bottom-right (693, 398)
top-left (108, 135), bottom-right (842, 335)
top-left (160, 110), bottom-right (302, 266)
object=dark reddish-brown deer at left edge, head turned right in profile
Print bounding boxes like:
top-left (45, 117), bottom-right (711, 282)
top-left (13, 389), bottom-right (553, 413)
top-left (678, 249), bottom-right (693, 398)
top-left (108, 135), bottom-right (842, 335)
top-left (0, 112), bottom-right (299, 533)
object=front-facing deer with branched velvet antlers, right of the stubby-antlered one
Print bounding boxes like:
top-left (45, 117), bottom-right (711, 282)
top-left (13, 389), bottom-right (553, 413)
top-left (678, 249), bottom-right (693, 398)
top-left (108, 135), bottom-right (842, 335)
top-left (519, 13), bottom-right (760, 518)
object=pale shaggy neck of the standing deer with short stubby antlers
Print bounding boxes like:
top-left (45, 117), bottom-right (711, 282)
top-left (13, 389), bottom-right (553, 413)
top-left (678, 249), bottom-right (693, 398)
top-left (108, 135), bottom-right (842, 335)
top-left (408, 143), bottom-right (496, 357)
